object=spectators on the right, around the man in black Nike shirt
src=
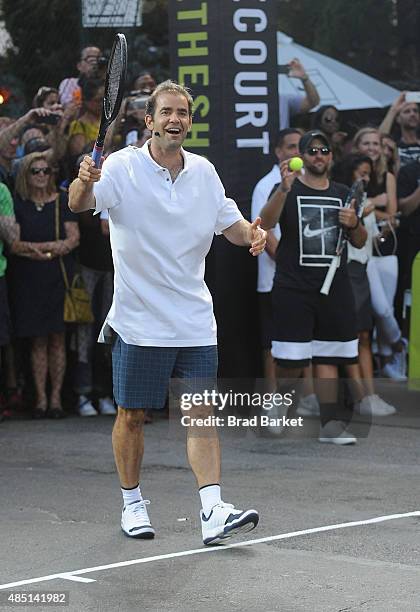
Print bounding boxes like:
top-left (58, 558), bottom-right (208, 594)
top-left (252, 81), bottom-right (420, 424)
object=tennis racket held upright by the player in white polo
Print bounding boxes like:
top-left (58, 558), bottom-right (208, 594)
top-left (92, 34), bottom-right (127, 168)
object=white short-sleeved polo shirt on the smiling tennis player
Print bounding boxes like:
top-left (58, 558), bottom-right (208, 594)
top-left (92, 141), bottom-right (243, 346)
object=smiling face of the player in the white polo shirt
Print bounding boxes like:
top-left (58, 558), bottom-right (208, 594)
top-left (145, 92), bottom-right (192, 149)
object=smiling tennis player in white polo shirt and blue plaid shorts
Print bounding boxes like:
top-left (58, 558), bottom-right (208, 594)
top-left (69, 81), bottom-right (266, 544)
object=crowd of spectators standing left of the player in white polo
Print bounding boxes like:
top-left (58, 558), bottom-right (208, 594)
top-left (0, 46), bottom-right (156, 420)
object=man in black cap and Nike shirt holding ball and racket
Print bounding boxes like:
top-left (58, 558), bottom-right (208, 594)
top-left (261, 131), bottom-right (367, 445)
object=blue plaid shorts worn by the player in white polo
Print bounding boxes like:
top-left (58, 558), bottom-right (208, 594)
top-left (112, 335), bottom-right (218, 410)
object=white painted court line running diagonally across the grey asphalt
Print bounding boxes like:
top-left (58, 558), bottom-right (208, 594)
top-left (0, 510), bottom-right (420, 590)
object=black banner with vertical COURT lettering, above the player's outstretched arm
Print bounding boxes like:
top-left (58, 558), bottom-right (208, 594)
top-left (168, 0), bottom-right (279, 217)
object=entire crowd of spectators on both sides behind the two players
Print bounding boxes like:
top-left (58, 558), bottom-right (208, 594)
top-left (0, 46), bottom-right (420, 426)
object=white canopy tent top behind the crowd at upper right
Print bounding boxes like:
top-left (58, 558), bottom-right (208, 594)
top-left (277, 32), bottom-right (400, 110)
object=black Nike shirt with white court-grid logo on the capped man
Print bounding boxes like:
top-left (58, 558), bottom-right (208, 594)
top-left (274, 179), bottom-right (349, 291)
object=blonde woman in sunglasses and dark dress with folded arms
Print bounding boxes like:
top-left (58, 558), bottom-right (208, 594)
top-left (11, 153), bottom-right (79, 418)
